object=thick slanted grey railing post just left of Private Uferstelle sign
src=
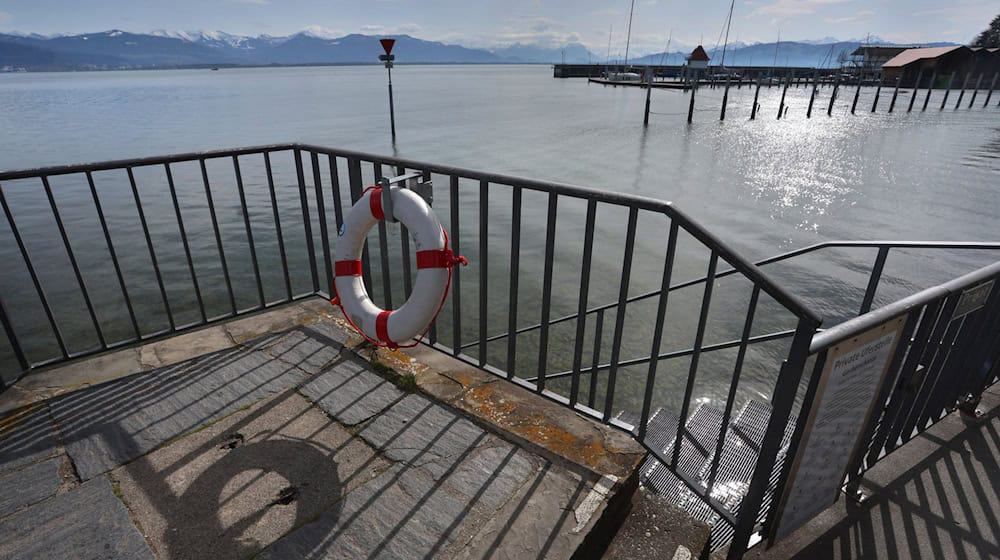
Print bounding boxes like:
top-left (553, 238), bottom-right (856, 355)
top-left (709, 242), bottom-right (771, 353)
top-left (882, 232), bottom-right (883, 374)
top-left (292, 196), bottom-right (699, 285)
top-left (726, 319), bottom-right (818, 560)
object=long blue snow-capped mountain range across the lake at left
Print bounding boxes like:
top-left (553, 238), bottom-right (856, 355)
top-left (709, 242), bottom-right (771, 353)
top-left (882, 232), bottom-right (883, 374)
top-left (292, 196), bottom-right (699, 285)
top-left (0, 29), bottom-right (596, 70)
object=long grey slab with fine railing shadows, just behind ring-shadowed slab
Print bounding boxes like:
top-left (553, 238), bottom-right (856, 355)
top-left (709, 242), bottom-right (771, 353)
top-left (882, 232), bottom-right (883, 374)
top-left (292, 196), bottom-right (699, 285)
top-left (50, 348), bottom-right (306, 480)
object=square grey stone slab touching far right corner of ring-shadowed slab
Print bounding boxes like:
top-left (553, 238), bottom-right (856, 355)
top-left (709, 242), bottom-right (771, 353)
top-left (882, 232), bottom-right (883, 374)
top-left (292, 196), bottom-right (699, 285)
top-left (299, 358), bottom-right (404, 426)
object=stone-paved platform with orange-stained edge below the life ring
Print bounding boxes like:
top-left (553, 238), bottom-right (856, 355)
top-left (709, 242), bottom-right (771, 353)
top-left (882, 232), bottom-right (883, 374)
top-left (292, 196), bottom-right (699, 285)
top-left (0, 303), bottom-right (644, 559)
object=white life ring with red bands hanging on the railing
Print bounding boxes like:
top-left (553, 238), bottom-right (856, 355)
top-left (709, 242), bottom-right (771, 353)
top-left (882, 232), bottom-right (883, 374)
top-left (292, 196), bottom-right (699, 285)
top-left (332, 186), bottom-right (468, 348)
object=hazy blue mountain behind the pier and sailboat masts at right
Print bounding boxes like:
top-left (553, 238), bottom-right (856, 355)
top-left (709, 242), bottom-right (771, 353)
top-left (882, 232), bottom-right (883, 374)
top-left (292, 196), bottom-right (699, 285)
top-left (629, 41), bottom-right (954, 67)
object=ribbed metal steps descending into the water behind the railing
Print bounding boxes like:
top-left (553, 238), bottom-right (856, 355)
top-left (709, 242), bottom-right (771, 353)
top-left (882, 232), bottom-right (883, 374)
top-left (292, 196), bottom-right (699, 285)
top-left (617, 399), bottom-right (794, 551)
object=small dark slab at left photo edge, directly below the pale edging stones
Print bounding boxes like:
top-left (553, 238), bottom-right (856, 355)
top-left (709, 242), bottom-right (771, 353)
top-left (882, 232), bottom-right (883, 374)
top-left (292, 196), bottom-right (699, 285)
top-left (0, 404), bottom-right (59, 473)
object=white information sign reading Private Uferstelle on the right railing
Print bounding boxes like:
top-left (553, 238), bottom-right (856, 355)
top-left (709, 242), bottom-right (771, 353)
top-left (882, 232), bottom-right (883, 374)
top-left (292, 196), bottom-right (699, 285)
top-left (771, 317), bottom-right (905, 542)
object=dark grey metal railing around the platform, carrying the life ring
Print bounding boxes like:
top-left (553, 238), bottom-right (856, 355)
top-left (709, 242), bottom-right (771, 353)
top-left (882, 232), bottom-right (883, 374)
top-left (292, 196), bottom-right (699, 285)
top-left (0, 144), bottom-right (1000, 557)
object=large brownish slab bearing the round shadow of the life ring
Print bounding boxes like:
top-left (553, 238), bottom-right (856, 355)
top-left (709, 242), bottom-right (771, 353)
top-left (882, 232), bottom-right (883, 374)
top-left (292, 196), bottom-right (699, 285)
top-left (111, 391), bottom-right (389, 560)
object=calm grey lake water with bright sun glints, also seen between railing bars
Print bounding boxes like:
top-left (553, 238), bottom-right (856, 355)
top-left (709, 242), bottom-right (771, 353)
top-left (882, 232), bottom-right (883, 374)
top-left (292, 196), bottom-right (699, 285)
top-left (0, 66), bottom-right (1000, 418)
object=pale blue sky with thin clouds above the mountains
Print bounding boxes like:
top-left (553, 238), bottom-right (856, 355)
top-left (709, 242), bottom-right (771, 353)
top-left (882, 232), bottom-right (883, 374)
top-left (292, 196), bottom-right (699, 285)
top-left (0, 0), bottom-right (1000, 54)
